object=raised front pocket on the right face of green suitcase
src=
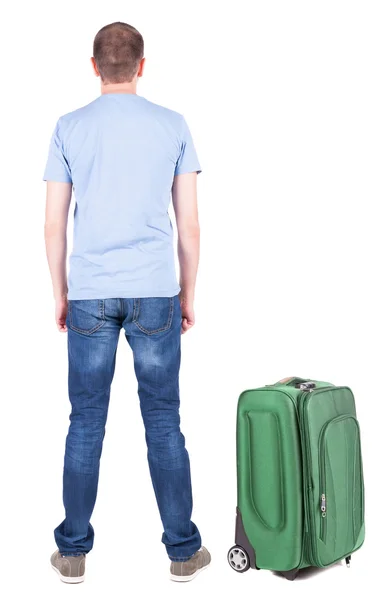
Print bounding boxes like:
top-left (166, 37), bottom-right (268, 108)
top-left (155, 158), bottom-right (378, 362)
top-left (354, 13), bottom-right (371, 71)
top-left (319, 415), bottom-right (363, 564)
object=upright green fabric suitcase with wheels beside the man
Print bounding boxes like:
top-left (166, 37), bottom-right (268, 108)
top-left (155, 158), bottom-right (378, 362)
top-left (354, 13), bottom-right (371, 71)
top-left (228, 377), bottom-right (365, 580)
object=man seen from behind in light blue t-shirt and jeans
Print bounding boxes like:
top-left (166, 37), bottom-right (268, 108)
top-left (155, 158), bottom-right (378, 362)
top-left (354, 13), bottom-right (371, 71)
top-left (44, 23), bottom-right (211, 583)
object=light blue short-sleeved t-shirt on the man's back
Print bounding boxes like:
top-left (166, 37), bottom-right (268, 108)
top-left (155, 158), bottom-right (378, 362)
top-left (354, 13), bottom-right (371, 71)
top-left (44, 94), bottom-right (200, 300)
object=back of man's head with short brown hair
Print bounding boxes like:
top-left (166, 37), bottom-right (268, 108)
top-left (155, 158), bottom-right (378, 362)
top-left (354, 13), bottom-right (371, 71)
top-left (93, 22), bottom-right (144, 83)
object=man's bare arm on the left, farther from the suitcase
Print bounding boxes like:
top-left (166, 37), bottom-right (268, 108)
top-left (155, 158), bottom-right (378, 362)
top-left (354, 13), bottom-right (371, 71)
top-left (45, 181), bottom-right (72, 332)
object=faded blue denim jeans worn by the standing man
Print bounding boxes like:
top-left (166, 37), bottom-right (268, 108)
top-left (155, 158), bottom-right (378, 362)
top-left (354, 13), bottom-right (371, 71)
top-left (54, 296), bottom-right (201, 561)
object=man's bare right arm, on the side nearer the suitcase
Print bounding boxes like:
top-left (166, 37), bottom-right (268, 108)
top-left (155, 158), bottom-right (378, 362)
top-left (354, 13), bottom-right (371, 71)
top-left (172, 172), bottom-right (200, 333)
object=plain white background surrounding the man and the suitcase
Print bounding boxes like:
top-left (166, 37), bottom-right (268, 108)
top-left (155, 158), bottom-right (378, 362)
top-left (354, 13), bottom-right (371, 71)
top-left (0, 0), bottom-right (382, 599)
